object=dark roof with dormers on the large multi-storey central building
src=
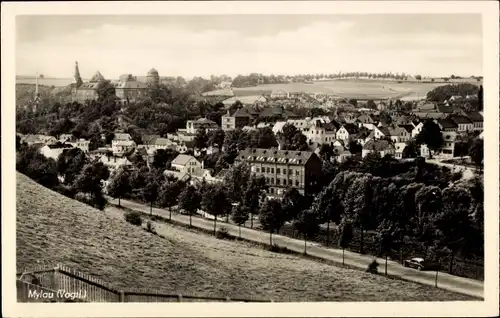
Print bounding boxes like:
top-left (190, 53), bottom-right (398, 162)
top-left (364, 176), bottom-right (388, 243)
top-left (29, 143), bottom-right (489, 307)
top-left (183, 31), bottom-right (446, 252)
top-left (238, 148), bottom-right (314, 165)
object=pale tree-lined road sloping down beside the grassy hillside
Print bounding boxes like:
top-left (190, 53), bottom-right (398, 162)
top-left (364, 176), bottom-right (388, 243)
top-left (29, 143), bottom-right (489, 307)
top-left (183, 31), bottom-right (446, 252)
top-left (108, 198), bottom-right (484, 298)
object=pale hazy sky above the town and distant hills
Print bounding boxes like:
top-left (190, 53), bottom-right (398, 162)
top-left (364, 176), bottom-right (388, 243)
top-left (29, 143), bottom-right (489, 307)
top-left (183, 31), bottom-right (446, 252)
top-left (16, 14), bottom-right (483, 79)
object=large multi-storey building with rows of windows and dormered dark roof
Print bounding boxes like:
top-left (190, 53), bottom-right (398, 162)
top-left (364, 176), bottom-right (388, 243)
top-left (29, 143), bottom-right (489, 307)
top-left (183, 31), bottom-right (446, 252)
top-left (237, 148), bottom-right (322, 197)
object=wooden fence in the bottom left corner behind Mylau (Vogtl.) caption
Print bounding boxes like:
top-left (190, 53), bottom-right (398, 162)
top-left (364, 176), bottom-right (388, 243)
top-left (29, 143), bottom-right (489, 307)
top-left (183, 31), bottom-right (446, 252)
top-left (16, 265), bottom-right (270, 302)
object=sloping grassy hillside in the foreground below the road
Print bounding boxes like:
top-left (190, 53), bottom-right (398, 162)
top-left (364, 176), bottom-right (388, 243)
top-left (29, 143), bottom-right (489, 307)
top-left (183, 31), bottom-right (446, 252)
top-left (16, 173), bottom-right (471, 301)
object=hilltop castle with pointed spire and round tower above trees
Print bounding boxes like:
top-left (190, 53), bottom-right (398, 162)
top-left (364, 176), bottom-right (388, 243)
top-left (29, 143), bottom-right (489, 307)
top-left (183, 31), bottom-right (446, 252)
top-left (71, 62), bottom-right (160, 105)
